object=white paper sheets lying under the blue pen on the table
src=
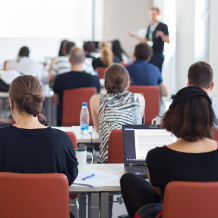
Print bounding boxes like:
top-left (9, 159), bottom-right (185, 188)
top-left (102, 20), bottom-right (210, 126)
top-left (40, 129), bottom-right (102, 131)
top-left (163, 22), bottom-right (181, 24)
top-left (74, 170), bottom-right (120, 187)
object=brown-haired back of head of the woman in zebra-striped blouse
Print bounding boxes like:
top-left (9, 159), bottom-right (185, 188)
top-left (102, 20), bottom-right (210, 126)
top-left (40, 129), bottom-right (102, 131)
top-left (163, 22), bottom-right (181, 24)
top-left (104, 64), bottom-right (130, 94)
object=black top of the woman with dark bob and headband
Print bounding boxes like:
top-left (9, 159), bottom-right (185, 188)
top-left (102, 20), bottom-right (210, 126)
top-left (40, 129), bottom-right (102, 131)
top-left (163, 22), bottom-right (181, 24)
top-left (146, 147), bottom-right (218, 199)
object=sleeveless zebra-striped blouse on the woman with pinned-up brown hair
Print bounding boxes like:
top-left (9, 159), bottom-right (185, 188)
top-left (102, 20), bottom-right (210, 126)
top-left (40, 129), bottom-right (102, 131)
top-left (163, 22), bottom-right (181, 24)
top-left (98, 92), bottom-right (142, 163)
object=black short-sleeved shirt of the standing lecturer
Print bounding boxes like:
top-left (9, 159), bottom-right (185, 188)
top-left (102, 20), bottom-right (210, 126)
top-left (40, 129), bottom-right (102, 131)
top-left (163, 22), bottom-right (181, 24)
top-left (145, 22), bottom-right (169, 55)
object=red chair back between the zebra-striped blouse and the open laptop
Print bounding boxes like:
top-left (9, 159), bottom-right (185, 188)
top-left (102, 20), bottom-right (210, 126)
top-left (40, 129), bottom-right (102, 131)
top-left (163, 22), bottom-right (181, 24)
top-left (108, 130), bottom-right (124, 163)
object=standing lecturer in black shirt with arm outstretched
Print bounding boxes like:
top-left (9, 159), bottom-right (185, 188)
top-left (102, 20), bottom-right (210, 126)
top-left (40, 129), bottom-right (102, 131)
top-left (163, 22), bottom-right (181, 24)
top-left (129, 7), bottom-right (170, 72)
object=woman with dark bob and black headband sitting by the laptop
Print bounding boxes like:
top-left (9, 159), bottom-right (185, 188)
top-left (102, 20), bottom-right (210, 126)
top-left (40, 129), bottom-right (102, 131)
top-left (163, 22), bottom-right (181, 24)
top-left (120, 87), bottom-right (218, 218)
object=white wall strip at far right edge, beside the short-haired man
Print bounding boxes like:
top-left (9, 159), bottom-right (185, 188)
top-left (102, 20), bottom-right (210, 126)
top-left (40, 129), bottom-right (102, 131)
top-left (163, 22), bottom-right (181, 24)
top-left (209, 0), bottom-right (218, 96)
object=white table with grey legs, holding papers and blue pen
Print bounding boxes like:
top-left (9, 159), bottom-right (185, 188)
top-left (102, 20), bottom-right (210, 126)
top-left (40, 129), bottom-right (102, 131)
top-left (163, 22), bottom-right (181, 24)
top-left (69, 164), bottom-right (125, 218)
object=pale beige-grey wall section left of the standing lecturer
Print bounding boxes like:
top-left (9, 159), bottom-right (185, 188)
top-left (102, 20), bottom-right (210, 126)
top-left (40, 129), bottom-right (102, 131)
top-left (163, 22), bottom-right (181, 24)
top-left (103, 0), bottom-right (152, 56)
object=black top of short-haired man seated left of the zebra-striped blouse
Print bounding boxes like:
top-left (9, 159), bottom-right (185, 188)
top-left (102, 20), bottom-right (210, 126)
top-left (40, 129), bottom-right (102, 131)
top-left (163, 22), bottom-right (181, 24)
top-left (53, 71), bottom-right (101, 125)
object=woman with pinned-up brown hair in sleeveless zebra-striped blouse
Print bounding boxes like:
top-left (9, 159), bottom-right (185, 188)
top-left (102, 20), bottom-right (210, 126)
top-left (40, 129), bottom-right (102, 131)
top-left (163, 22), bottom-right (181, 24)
top-left (90, 64), bottom-right (145, 163)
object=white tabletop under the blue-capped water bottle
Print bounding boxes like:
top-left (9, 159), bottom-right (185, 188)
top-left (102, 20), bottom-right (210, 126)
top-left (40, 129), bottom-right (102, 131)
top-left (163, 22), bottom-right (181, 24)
top-left (53, 126), bottom-right (99, 144)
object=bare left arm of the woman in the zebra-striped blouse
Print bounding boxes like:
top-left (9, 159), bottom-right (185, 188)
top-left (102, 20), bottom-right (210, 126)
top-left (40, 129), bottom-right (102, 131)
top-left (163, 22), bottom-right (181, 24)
top-left (90, 95), bottom-right (100, 133)
